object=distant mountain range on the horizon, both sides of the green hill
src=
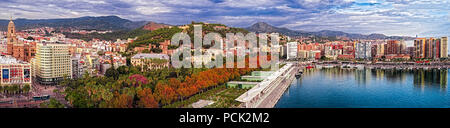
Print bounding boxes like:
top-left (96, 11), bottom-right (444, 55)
top-left (0, 16), bottom-right (414, 40)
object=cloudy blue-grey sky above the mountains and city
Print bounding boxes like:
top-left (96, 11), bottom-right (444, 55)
top-left (0, 0), bottom-right (450, 37)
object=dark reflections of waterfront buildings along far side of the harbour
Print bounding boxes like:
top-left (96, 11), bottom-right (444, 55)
top-left (304, 68), bottom-right (448, 91)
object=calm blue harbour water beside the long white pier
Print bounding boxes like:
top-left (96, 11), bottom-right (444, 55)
top-left (275, 68), bottom-right (450, 108)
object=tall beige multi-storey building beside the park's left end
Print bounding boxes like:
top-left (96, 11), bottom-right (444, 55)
top-left (32, 43), bottom-right (72, 85)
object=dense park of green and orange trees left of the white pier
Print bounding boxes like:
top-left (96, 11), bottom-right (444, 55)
top-left (62, 53), bottom-right (260, 108)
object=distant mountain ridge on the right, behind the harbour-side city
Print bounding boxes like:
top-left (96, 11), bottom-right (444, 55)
top-left (245, 22), bottom-right (414, 40)
